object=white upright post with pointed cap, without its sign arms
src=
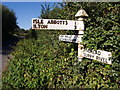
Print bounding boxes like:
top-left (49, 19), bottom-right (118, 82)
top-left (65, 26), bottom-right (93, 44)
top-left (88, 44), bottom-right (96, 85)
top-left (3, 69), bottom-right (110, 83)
top-left (75, 9), bottom-right (88, 61)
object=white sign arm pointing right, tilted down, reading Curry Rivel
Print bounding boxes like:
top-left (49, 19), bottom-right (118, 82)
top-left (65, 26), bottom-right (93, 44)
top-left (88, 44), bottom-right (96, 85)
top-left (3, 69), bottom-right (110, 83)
top-left (83, 48), bottom-right (112, 64)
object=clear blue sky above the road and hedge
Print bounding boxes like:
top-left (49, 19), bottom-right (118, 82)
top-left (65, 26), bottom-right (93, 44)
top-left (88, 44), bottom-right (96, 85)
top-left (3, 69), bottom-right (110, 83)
top-left (2, 2), bottom-right (62, 30)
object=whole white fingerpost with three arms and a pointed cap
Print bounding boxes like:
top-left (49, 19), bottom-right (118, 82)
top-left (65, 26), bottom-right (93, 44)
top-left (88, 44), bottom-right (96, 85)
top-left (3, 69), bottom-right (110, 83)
top-left (32, 9), bottom-right (112, 64)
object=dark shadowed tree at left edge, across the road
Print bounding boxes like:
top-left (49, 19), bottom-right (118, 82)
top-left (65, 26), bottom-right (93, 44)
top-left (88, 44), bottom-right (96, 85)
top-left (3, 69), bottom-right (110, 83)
top-left (2, 5), bottom-right (19, 39)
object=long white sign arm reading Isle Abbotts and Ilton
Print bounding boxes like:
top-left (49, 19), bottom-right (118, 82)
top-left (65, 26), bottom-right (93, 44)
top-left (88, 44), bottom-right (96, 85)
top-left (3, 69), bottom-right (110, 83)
top-left (32, 18), bottom-right (84, 30)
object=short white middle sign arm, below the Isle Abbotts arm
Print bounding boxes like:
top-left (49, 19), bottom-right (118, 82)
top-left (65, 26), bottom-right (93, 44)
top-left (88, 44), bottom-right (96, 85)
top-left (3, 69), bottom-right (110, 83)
top-left (59, 35), bottom-right (83, 43)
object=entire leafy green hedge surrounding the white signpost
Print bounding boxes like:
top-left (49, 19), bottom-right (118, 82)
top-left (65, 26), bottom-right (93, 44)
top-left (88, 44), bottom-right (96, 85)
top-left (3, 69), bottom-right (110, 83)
top-left (3, 2), bottom-right (120, 89)
